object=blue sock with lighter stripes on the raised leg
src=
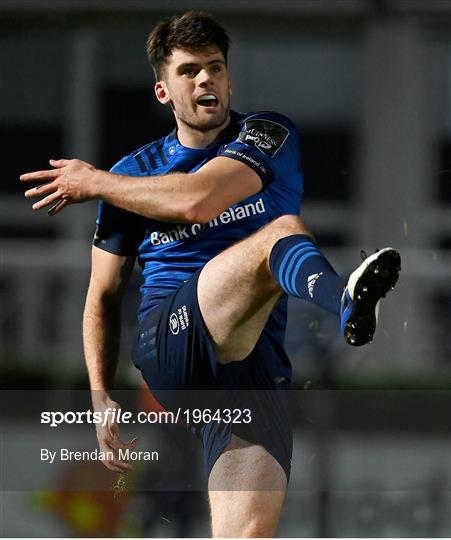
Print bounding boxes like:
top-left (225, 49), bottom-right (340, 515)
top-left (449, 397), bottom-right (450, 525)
top-left (269, 234), bottom-right (347, 315)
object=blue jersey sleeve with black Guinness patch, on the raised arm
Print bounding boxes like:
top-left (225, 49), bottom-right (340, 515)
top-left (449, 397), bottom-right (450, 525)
top-left (218, 112), bottom-right (300, 189)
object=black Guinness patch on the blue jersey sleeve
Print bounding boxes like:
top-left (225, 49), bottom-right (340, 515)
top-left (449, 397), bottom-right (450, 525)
top-left (238, 118), bottom-right (290, 157)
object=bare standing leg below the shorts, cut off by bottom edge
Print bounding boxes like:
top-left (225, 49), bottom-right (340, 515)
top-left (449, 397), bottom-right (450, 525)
top-left (208, 436), bottom-right (287, 538)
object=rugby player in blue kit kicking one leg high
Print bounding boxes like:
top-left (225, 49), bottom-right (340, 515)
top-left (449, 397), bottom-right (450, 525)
top-left (21, 11), bottom-right (400, 537)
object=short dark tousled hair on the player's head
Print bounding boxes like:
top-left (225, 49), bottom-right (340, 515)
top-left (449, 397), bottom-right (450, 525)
top-left (147, 11), bottom-right (230, 79)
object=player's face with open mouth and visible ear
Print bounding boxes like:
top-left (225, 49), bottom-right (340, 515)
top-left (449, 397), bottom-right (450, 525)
top-left (155, 48), bottom-right (231, 132)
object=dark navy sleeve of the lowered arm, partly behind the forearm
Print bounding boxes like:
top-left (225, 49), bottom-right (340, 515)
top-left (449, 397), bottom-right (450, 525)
top-left (92, 160), bottom-right (145, 257)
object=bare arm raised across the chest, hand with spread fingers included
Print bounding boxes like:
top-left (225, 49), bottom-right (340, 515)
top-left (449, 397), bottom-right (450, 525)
top-left (20, 157), bottom-right (262, 223)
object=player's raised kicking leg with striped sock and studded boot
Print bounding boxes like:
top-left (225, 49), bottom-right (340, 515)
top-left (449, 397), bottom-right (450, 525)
top-left (198, 215), bottom-right (400, 362)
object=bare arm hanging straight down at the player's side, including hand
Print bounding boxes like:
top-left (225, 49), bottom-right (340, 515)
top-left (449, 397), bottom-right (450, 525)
top-left (83, 247), bottom-right (138, 472)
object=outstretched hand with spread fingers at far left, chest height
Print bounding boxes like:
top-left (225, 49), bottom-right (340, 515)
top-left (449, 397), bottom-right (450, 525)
top-left (20, 159), bottom-right (97, 215)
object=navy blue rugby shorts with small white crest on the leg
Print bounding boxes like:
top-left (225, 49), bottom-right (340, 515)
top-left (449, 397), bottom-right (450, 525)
top-left (133, 270), bottom-right (293, 479)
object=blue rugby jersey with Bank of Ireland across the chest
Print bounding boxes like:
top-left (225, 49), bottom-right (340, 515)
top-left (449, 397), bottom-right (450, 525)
top-left (93, 108), bottom-right (302, 372)
